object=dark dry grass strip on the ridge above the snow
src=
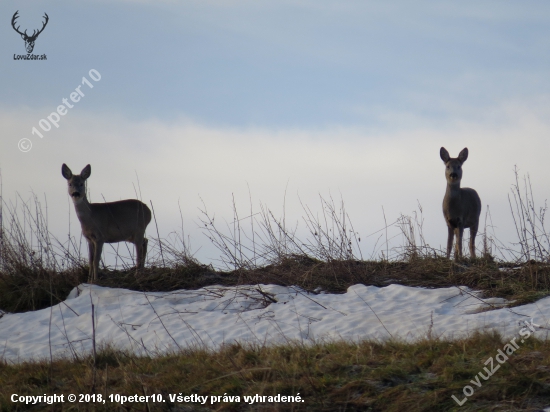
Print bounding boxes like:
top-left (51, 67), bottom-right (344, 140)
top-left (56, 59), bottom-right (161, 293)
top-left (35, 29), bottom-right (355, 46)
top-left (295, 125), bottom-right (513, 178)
top-left (4, 251), bottom-right (550, 312)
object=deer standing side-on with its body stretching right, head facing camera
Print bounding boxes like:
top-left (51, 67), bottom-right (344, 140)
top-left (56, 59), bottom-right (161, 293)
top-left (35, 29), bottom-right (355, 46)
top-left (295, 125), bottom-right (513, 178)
top-left (61, 163), bottom-right (151, 283)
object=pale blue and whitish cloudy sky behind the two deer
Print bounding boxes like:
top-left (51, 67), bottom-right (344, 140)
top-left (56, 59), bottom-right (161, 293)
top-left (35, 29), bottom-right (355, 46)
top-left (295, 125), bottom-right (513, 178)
top-left (0, 0), bottom-right (550, 262)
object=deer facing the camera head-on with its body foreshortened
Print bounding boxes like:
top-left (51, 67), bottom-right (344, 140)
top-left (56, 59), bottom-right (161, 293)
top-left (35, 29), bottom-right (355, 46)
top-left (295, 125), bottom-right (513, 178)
top-left (439, 147), bottom-right (481, 259)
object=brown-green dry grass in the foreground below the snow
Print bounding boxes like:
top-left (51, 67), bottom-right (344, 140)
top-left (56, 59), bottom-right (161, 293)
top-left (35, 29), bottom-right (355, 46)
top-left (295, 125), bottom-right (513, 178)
top-left (0, 334), bottom-right (550, 412)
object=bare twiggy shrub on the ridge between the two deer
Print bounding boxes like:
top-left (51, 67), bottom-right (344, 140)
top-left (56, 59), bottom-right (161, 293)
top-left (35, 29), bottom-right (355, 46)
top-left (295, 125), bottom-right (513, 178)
top-left (201, 196), bottom-right (363, 270)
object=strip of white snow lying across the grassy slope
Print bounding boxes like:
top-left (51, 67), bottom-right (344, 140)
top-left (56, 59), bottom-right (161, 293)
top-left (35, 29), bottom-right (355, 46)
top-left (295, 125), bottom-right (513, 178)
top-left (0, 284), bottom-right (550, 362)
